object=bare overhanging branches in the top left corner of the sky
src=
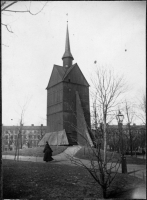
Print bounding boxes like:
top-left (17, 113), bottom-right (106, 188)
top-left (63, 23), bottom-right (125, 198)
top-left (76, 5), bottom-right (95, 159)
top-left (1, 1), bottom-right (48, 34)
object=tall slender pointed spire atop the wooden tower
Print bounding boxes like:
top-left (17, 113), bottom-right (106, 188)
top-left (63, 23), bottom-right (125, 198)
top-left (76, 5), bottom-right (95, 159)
top-left (62, 21), bottom-right (74, 67)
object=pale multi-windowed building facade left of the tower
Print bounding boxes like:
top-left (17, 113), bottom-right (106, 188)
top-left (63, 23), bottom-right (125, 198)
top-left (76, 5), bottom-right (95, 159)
top-left (2, 124), bottom-right (47, 151)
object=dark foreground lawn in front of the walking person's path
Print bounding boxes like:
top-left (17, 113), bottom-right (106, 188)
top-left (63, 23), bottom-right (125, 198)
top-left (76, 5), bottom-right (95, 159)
top-left (3, 160), bottom-right (145, 200)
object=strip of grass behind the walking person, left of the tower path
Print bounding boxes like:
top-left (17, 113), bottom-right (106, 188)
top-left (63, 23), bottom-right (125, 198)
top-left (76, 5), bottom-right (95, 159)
top-left (2, 146), bottom-right (67, 157)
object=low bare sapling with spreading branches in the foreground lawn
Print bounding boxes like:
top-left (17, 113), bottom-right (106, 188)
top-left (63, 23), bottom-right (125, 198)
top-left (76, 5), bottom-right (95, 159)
top-left (67, 124), bottom-right (120, 198)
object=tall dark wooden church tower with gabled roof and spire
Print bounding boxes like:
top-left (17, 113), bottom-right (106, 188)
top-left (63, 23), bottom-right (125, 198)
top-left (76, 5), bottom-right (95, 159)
top-left (46, 25), bottom-right (92, 145)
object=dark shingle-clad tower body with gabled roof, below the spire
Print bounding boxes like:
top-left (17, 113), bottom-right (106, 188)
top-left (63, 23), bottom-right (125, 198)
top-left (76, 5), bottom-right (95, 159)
top-left (46, 64), bottom-right (91, 144)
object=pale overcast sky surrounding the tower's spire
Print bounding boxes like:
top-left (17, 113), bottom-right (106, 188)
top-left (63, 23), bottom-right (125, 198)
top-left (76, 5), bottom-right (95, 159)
top-left (2, 1), bottom-right (146, 126)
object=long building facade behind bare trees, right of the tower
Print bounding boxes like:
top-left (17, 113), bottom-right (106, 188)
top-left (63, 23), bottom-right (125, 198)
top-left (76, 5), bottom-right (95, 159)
top-left (93, 124), bottom-right (146, 152)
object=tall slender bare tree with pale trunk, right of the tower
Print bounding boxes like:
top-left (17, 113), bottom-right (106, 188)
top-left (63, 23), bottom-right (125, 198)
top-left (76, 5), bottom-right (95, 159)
top-left (92, 67), bottom-right (126, 164)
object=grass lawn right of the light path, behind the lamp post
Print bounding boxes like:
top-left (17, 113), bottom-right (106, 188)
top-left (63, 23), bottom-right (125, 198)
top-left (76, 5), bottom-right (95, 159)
top-left (75, 147), bottom-right (146, 165)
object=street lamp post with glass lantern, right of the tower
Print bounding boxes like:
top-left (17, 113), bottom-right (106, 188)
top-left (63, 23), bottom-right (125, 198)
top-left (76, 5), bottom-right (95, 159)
top-left (116, 110), bottom-right (127, 174)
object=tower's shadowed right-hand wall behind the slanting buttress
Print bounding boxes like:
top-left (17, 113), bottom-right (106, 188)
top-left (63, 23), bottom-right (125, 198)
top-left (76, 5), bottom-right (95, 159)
top-left (63, 82), bottom-right (90, 132)
